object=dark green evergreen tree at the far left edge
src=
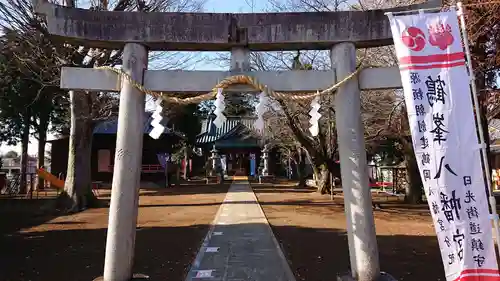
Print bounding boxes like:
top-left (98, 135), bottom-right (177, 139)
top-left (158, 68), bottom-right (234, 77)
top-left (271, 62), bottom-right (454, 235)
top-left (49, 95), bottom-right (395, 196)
top-left (0, 29), bottom-right (67, 192)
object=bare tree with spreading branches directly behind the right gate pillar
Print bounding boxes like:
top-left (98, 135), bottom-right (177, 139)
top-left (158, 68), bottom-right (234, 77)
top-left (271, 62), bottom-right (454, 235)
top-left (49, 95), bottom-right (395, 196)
top-left (207, 0), bottom-right (396, 193)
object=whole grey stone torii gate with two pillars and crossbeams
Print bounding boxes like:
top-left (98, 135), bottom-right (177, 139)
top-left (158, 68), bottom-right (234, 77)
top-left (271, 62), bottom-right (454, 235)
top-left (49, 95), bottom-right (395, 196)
top-left (34, 0), bottom-right (441, 281)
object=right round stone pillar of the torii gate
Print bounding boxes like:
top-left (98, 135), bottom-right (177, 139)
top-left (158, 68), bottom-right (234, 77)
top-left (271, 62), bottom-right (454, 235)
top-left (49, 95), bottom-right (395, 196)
top-left (331, 43), bottom-right (380, 281)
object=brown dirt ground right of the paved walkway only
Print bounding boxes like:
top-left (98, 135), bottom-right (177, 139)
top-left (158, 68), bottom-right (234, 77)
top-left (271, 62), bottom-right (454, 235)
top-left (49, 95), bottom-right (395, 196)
top-left (253, 182), bottom-right (445, 281)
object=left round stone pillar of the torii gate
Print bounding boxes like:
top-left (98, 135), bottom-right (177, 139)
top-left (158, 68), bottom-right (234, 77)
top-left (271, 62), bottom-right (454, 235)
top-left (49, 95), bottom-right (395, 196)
top-left (104, 43), bottom-right (148, 281)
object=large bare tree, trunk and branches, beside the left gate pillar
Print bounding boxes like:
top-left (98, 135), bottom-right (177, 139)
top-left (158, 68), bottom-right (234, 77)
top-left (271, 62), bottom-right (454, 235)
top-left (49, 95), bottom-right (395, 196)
top-left (0, 0), bottom-right (204, 211)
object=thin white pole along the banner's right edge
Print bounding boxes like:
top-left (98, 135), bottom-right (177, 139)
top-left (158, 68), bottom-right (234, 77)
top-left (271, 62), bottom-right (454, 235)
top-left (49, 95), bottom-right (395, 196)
top-left (457, 2), bottom-right (500, 256)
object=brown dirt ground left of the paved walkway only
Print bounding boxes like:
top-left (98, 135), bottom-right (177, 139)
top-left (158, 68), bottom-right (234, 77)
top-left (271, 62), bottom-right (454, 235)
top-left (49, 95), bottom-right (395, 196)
top-left (0, 185), bottom-right (228, 281)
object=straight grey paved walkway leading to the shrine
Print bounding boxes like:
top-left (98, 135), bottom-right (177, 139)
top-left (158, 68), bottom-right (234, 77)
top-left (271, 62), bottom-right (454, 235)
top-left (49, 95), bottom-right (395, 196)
top-left (186, 181), bottom-right (295, 281)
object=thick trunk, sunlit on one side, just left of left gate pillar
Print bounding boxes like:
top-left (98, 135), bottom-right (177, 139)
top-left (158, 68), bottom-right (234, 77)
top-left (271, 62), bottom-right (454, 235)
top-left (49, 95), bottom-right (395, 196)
top-left (60, 91), bottom-right (97, 212)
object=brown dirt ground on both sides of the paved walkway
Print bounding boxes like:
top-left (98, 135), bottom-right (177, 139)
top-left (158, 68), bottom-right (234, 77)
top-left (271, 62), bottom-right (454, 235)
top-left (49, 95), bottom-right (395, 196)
top-left (0, 179), bottom-right (460, 281)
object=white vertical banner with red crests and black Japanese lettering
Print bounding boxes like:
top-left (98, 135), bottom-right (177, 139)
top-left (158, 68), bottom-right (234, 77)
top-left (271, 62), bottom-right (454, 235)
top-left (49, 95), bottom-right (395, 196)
top-left (389, 11), bottom-right (500, 281)
